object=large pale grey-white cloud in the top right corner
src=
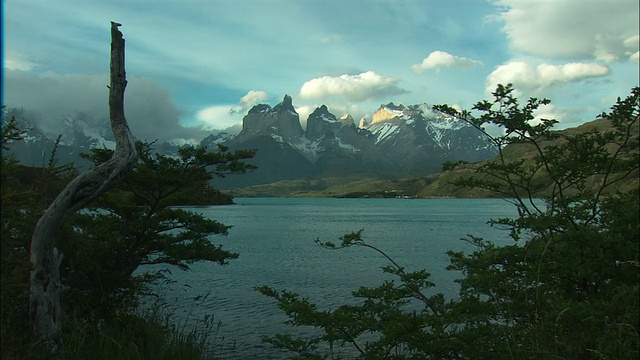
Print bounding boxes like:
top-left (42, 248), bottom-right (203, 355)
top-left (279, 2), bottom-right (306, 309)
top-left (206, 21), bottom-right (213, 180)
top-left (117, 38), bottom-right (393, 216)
top-left (494, 0), bottom-right (639, 62)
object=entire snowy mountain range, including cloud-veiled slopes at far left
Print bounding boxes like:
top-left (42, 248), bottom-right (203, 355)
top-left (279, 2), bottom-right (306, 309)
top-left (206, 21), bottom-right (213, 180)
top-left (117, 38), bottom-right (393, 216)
top-left (2, 95), bottom-right (495, 189)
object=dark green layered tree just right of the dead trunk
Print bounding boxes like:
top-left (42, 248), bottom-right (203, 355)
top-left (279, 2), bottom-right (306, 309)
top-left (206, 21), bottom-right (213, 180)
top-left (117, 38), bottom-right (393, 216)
top-left (60, 142), bottom-right (254, 318)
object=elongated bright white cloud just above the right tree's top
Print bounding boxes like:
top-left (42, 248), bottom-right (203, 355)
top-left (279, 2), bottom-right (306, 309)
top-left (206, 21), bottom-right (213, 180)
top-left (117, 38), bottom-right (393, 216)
top-left (486, 61), bottom-right (610, 94)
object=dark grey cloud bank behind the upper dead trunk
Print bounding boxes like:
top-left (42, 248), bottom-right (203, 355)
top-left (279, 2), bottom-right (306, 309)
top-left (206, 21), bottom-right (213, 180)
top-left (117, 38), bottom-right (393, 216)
top-left (4, 69), bottom-right (203, 141)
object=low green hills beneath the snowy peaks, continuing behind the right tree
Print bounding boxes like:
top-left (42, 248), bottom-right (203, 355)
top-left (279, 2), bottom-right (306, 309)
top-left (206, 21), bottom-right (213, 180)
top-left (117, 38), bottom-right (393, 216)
top-left (226, 119), bottom-right (639, 198)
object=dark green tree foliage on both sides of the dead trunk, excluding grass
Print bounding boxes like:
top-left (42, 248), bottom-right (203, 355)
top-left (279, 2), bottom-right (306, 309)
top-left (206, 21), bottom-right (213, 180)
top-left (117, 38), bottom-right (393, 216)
top-left (0, 112), bottom-right (254, 358)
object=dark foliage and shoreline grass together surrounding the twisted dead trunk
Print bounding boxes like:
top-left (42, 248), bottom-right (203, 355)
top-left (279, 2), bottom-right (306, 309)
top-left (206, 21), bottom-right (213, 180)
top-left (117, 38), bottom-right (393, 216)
top-left (0, 111), bottom-right (253, 359)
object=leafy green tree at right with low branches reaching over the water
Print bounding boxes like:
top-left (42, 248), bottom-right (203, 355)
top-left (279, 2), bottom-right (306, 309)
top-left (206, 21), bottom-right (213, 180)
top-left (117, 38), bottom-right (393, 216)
top-left (258, 85), bottom-right (640, 359)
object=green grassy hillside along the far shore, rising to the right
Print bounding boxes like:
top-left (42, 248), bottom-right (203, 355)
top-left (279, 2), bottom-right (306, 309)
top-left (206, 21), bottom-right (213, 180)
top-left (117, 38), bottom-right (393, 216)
top-left (226, 119), bottom-right (639, 198)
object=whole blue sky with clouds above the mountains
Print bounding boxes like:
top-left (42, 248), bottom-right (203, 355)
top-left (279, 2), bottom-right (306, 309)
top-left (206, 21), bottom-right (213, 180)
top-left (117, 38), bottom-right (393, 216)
top-left (2, 0), bottom-right (640, 140)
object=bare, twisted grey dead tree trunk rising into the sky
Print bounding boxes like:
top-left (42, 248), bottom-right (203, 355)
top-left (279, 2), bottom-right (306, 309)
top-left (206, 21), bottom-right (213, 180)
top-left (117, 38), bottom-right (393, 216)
top-left (29, 22), bottom-right (137, 342)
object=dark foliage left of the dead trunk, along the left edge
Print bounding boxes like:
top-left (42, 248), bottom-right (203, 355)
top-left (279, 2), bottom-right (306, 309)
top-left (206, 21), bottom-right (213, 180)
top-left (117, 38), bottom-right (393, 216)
top-left (0, 117), bottom-right (77, 358)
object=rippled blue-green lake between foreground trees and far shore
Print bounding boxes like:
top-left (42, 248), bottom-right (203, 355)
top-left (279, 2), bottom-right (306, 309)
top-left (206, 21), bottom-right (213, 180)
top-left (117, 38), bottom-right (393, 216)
top-left (141, 198), bottom-right (517, 359)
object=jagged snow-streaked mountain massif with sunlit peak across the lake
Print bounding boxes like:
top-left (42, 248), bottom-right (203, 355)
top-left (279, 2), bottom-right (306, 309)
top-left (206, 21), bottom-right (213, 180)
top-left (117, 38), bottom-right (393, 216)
top-left (216, 95), bottom-right (495, 189)
